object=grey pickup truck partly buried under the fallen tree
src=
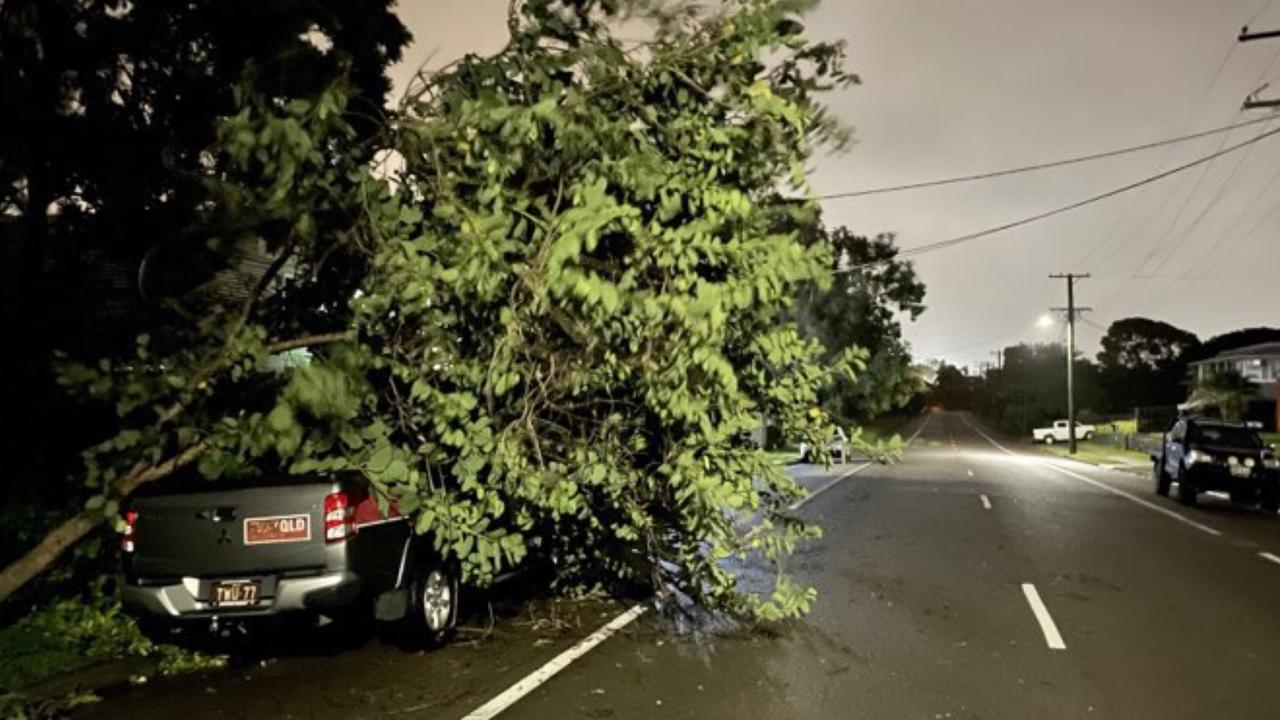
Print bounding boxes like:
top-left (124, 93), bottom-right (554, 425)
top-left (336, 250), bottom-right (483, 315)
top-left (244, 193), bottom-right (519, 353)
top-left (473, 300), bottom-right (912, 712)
top-left (122, 478), bottom-right (458, 647)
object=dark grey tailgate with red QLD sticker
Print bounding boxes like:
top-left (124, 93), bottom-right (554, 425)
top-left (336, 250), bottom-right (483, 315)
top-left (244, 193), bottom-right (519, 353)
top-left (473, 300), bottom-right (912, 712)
top-left (127, 482), bottom-right (340, 580)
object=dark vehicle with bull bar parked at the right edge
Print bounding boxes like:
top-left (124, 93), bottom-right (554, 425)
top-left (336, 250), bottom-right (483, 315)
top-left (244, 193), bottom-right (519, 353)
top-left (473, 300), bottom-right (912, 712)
top-left (1152, 418), bottom-right (1280, 512)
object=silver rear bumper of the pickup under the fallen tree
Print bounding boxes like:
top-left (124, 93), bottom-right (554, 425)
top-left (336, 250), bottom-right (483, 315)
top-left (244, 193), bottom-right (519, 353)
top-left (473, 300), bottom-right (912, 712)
top-left (120, 571), bottom-right (361, 619)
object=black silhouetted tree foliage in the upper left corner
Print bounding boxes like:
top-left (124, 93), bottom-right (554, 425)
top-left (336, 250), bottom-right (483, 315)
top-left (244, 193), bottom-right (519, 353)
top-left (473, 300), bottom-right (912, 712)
top-left (0, 0), bottom-right (408, 562)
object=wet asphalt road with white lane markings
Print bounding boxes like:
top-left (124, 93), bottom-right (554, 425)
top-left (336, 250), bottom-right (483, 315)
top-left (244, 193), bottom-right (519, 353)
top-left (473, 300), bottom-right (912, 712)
top-left (86, 413), bottom-right (1280, 720)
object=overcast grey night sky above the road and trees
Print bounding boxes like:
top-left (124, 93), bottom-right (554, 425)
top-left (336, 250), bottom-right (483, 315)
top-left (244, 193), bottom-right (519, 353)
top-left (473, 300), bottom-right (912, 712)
top-left (393, 0), bottom-right (1280, 364)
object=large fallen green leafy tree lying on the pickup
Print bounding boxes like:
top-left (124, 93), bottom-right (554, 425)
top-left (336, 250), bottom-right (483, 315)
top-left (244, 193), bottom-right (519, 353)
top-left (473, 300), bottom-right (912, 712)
top-left (0, 0), bottom-right (856, 619)
